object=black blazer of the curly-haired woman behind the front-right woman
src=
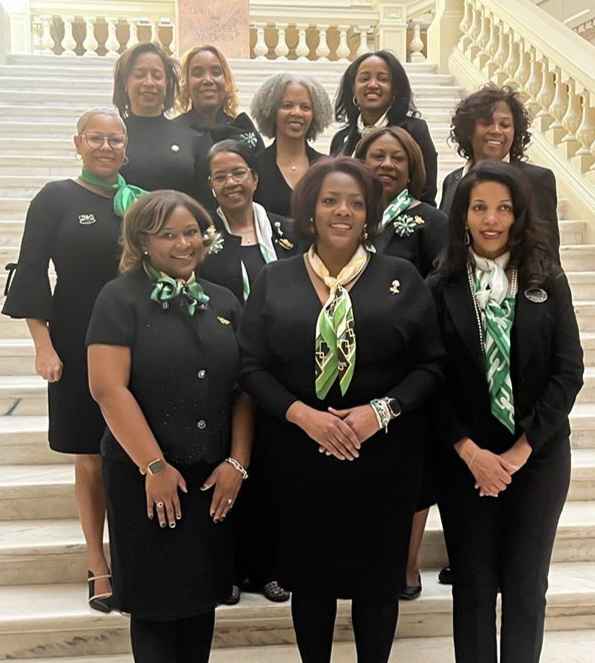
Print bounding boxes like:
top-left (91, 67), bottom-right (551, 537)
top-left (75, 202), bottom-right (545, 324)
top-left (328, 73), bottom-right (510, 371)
top-left (440, 161), bottom-right (560, 260)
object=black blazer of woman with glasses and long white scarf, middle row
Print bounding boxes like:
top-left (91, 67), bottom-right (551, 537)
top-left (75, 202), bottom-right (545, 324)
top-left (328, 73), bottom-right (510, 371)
top-left (200, 211), bottom-right (301, 303)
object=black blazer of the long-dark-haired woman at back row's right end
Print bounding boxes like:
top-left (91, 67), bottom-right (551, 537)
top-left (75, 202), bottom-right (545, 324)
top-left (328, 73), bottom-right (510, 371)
top-left (331, 117), bottom-right (438, 207)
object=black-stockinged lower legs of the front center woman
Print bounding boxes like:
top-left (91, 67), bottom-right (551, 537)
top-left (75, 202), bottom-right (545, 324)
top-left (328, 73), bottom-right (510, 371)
top-left (291, 590), bottom-right (399, 663)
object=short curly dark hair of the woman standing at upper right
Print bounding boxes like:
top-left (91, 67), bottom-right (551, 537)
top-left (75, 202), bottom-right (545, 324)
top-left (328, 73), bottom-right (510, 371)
top-left (449, 83), bottom-right (531, 161)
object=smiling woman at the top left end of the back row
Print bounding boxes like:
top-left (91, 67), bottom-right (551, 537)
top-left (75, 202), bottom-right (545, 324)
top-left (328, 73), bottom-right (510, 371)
top-left (113, 43), bottom-right (211, 205)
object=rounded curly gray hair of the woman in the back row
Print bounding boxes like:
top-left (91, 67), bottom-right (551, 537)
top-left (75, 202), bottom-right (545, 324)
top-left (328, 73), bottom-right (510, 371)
top-left (250, 74), bottom-right (333, 140)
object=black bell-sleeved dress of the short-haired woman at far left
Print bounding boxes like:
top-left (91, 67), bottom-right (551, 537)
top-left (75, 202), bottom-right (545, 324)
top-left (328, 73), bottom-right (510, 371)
top-left (2, 180), bottom-right (120, 454)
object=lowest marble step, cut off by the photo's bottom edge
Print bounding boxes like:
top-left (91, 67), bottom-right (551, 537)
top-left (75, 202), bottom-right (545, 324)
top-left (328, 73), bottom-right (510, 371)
top-left (10, 630), bottom-right (595, 663)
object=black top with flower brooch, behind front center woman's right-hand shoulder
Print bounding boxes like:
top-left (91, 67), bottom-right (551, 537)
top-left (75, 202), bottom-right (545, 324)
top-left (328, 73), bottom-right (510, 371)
top-left (374, 203), bottom-right (448, 278)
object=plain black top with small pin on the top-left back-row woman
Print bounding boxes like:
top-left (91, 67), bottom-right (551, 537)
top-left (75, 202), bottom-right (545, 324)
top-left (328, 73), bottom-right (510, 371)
top-left (121, 115), bottom-right (212, 206)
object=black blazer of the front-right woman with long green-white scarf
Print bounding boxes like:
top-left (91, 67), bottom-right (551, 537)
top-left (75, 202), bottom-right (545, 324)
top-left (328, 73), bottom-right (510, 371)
top-left (428, 272), bottom-right (583, 453)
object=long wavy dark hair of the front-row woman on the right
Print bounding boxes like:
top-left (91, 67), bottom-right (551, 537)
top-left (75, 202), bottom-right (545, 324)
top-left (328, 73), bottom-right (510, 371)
top-left (438, 161), bottom-right (560, 288)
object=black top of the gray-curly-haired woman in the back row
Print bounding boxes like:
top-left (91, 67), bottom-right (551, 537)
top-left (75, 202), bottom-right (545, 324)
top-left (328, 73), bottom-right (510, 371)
top-left (254, 141), bottom-right (325, 217)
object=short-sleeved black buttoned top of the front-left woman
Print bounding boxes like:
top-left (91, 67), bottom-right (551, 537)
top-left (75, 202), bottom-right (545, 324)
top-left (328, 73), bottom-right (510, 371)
top-left (87, 269), bottom-right (241, 464)
